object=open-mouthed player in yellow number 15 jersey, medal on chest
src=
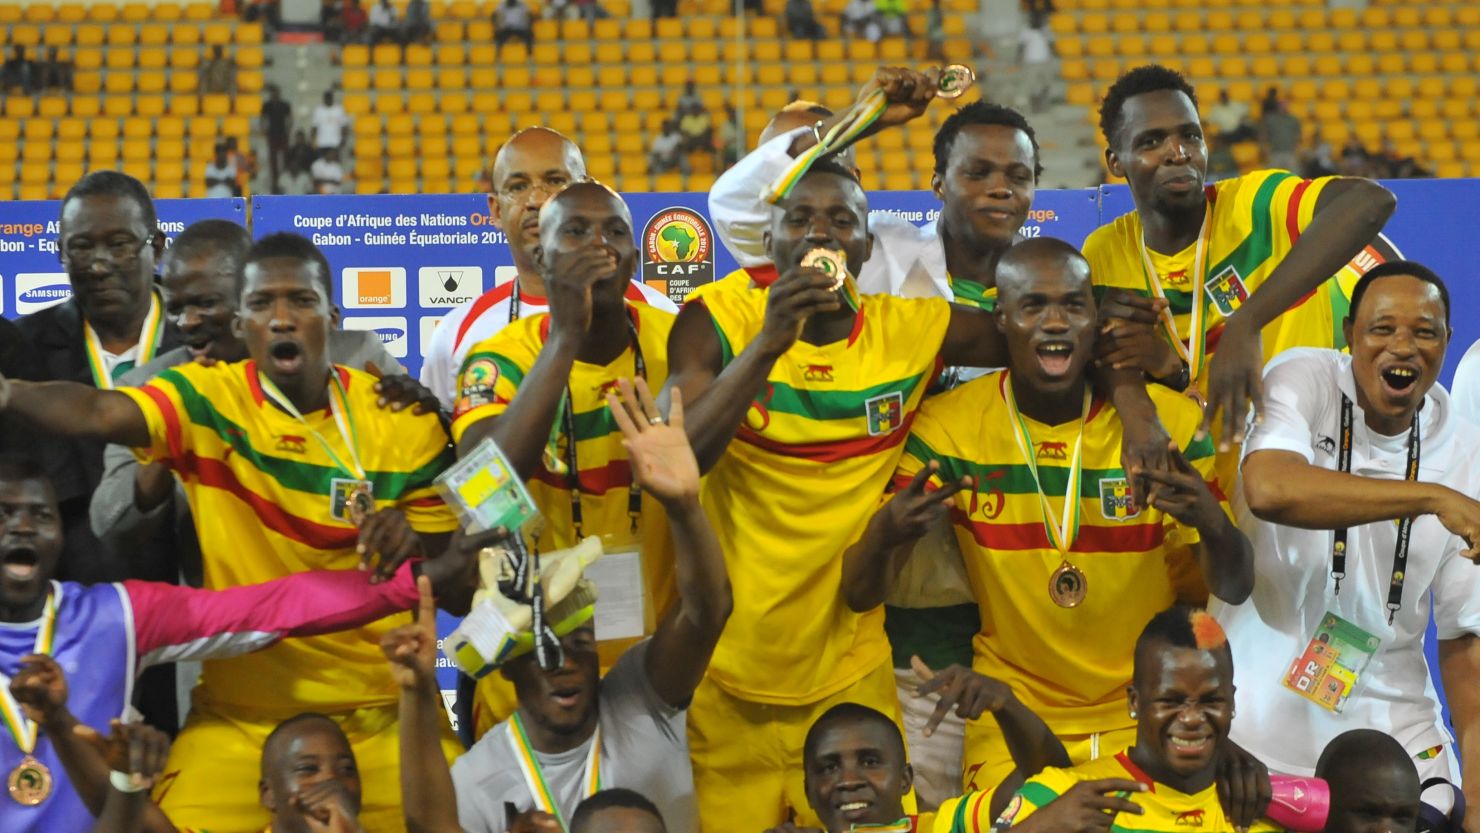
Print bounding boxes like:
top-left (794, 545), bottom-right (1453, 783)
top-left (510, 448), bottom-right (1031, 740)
top-left (844, 237), bottom-right (1254, 790)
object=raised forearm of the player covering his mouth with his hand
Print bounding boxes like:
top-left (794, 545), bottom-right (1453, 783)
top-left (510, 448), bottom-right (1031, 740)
top-left (457, 249), bottom-right (616, 478)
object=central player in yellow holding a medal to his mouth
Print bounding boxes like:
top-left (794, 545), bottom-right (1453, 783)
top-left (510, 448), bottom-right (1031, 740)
top-left (669, 160), bottom-right (1165, 829)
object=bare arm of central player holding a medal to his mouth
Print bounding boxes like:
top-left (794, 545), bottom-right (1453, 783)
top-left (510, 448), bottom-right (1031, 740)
top-left (665, 268), bottom-right (841, 472)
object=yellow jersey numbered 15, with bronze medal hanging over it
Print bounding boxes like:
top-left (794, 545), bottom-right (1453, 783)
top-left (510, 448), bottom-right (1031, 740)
top-left (895, 370), bottom-right (1228, 735)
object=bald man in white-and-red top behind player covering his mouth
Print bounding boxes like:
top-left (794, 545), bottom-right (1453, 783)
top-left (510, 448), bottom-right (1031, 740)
top-left (422, 127), bottom-right (678, 411)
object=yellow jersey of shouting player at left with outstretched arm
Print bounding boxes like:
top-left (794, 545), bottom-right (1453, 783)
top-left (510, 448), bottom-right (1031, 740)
top-left (120, 361), bottom-right (457, 718)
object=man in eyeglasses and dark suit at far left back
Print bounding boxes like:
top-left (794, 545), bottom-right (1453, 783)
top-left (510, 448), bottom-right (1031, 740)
top-left (16, 170), bottom-right (181, 583)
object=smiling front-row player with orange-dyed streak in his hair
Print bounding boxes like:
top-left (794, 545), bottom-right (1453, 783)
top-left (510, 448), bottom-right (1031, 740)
top-left (998, 605), bottom-right (1280, 833)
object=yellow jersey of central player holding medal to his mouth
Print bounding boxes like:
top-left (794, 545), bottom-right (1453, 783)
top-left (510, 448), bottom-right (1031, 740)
top-left (702, 289), bottom-right (950, 706)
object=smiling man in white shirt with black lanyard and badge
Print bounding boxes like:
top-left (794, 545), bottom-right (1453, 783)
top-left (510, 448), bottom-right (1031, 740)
top-left (1211, 260), bottom-right (1480, 816)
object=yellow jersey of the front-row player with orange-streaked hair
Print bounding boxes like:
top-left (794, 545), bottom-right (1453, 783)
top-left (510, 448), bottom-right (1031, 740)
top-left (998, 750), bottom-right (1282, 833)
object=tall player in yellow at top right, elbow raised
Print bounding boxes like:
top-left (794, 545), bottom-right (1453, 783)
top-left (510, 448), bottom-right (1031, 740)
top-left (1085, 65), bottom-right (1397, 470)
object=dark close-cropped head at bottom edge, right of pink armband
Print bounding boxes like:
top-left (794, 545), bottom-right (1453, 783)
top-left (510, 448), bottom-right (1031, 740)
top-left (1316, 729), bottom-right (1422, 833)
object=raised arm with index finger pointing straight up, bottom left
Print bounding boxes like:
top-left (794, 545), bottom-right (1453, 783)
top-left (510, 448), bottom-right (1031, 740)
top-left (380, 577), bottom-right (463, 833)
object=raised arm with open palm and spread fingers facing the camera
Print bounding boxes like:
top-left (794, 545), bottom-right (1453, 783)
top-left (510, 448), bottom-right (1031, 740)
top-left (607, 379), bottom-right (734, 709)
